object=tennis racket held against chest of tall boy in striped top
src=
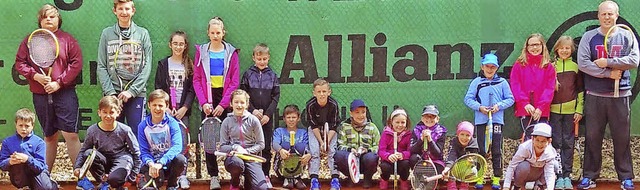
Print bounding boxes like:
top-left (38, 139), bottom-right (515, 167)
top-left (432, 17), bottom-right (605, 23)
top-left (113, 41), bottom-right (146, 92)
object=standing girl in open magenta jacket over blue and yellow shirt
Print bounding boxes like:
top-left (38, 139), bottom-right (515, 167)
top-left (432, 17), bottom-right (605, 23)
top-left (193, 17), bottom-right (240, 189)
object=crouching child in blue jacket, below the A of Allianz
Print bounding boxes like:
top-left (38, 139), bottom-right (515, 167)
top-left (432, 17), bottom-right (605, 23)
top-left (271, 104), bottom-right (311, 190)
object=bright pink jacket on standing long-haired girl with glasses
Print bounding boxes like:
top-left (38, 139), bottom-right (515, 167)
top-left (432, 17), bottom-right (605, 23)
top-left (509, 53), bottom-right (556, 117)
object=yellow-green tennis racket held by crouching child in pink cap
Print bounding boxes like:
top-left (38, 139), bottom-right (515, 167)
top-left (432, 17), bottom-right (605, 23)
top-left (427, 153), bottom-right (487, 183)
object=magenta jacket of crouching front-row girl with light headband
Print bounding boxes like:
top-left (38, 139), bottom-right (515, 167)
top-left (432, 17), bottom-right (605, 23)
top-left (378, 126), bottom-right (411, 162)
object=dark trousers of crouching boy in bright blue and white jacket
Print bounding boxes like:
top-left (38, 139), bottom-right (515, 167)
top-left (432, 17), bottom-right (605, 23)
top-left (138, 154), bottom-right (187, 188)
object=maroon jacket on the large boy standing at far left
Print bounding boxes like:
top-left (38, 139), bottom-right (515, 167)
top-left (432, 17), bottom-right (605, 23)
top-left (15, 29), bottom-right (82, 94)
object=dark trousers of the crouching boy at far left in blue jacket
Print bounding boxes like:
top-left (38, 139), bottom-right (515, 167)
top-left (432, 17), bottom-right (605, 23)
top-left (9, 163), bottom-right (58, 190)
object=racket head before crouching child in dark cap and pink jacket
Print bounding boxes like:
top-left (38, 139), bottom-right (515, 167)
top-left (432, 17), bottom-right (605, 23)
top-left (411, 160), bottom-right (438, 189)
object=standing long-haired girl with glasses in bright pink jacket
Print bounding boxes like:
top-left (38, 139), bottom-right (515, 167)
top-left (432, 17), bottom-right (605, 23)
top-left (510, 33), bottom-right (556, 139)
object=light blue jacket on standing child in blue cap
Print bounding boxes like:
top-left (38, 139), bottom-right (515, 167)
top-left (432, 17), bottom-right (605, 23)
top-left (464, 74), bottom-right (514, 125)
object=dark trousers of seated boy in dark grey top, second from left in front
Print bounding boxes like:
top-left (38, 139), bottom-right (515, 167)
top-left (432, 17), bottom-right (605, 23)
top-left (81, 149), bottom-right (135, 188)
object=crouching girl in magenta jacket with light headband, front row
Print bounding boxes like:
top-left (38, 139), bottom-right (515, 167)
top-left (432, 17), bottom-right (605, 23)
top-left (378, 108), bottom-right (411, 190)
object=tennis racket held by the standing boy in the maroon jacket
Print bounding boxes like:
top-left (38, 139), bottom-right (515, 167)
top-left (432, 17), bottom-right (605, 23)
top-left (27, 29), bottom-right (60, 104)
